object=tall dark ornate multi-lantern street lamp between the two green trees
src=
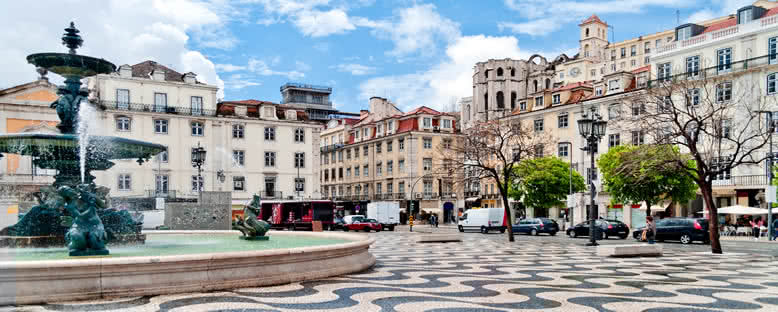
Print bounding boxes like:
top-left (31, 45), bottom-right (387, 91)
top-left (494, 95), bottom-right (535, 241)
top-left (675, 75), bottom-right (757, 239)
top-left (578, 106), bottom-right (608, 246)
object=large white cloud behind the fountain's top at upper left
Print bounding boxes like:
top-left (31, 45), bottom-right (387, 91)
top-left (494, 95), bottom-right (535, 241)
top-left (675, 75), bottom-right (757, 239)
top-left (0, 0), bottom-right (227, 97)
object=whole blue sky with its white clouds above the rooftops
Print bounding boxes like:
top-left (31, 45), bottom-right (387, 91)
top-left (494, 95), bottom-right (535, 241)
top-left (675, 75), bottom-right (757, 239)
top-left (0, 0), bottom-right (752, 111)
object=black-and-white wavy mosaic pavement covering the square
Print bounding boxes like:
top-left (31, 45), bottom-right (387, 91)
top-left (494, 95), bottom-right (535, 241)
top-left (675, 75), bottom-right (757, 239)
top-left (0, 232), bottom-right (778, 312)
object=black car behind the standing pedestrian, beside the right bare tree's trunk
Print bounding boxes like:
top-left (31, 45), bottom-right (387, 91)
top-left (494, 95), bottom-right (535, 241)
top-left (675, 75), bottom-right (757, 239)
top-left (632, 218), bottom-right (710, 244)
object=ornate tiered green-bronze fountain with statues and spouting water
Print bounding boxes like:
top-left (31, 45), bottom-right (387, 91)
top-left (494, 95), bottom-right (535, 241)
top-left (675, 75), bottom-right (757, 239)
top-left (0, 22), bottom-right (166, 256)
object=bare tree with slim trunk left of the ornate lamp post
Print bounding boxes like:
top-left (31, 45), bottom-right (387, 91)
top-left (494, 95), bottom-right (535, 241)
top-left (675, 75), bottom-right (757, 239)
top-left (439, 118), bottom-right (552, 242)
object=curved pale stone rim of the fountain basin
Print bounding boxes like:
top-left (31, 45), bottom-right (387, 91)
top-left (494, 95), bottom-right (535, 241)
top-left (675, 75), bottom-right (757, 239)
top-left (0, 231), bottom-right (376, 305)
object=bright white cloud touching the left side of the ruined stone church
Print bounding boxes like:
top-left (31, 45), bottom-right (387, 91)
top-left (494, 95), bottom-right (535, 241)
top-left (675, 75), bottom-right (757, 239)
top-left (359, 35), bottom-right (531, 110)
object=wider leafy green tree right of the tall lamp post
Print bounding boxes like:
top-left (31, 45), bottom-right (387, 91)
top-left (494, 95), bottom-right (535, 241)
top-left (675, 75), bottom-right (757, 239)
top-left (597, 145), bottom-right (697, 215)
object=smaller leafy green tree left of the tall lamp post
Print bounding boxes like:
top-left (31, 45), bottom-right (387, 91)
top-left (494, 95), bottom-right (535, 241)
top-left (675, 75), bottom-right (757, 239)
top-left (508, 157), bottom-right (586, 209)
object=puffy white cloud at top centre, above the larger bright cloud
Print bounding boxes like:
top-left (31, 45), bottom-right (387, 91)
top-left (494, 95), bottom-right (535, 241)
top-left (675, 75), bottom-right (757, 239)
top-left (358, 4), bottom-right (460, 56)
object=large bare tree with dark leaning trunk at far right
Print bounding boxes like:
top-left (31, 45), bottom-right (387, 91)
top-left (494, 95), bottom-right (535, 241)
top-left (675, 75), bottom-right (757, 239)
top-left (621, 63), bottom-right (775, 253)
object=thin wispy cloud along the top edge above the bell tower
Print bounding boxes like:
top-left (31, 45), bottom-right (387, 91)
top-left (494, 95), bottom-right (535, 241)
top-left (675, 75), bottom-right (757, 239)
top-left (497, 0), bottom-right (697, 36)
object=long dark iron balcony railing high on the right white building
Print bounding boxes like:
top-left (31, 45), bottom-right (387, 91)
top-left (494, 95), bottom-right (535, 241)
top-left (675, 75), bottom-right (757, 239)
top-left (648, 54), bottom-right (778, 88)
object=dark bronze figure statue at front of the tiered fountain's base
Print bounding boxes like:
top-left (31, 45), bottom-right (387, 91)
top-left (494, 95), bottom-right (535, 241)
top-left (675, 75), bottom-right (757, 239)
top-left (58, 184), bottom-right (108, 256)
